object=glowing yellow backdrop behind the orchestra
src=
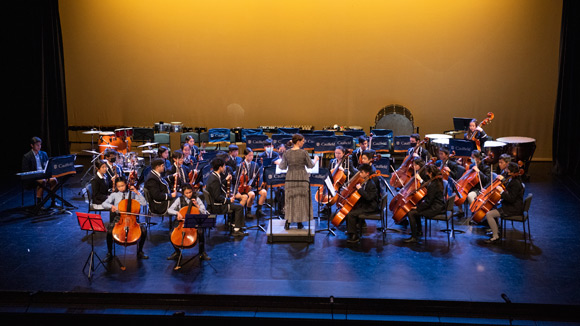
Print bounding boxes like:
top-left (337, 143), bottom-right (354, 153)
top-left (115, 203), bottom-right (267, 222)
top-left (59, 0), bottom-right (562, 159)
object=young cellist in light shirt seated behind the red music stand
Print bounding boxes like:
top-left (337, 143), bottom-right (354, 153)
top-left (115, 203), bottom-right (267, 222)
top-left (103, 177), bottom-right (149, 261)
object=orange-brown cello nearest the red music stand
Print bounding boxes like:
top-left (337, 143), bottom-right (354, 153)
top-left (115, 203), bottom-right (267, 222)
top-left (113, 185), bottom-right (141, 258)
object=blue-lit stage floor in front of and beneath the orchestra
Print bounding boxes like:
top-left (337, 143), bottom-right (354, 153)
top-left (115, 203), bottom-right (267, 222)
top-left (0, 162), bottom-right (580, 324)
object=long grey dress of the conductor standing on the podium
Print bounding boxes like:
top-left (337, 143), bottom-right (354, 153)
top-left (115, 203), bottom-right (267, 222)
top-left (279, 149), bottom-right (314, 223)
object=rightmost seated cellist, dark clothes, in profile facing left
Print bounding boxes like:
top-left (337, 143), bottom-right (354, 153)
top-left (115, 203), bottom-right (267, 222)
top-left (485, 162), bottom-right (525, 243)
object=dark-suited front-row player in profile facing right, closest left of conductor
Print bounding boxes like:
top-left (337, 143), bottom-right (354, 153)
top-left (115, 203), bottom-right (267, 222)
top-left (205, 158), bottom-right (248, 236)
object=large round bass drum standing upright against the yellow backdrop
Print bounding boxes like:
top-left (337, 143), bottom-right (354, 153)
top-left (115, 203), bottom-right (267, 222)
top-left (374, 104), bottom-right (415, 136)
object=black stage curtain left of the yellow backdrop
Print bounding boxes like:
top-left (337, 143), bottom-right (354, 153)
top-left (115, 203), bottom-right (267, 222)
top-left (1, 0), bottom-right (69, 180)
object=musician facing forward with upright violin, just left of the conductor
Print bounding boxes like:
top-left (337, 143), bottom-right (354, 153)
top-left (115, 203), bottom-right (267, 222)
top-left (234, 148), bottom-right (267, 217)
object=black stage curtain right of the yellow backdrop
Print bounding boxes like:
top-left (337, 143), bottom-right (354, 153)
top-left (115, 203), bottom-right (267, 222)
top-left (552, 0), bottom-right (580, 181)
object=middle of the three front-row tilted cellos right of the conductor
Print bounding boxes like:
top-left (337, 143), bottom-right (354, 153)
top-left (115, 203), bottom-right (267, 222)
top-left (389, 158), bottom-right (441, 223)
